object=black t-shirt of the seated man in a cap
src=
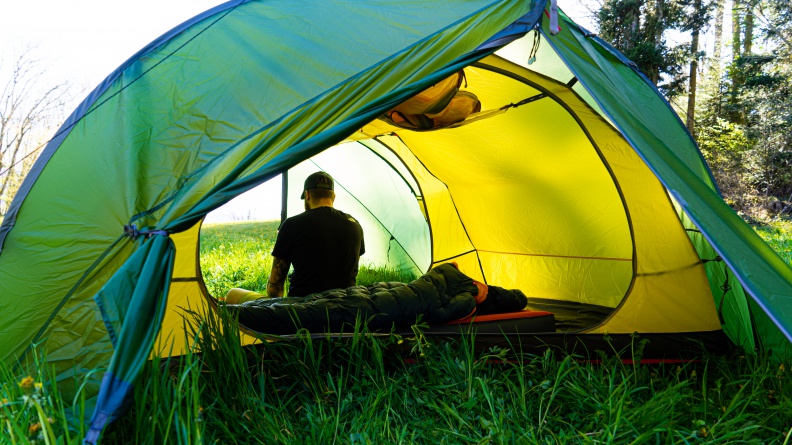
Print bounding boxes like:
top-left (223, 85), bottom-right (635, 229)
top-left (272, 207), bottom-right (366, 297)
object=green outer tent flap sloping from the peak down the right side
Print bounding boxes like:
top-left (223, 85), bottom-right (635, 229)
top-left (546, 11), bottom-right (792, 341)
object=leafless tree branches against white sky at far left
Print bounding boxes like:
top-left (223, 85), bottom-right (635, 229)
top-left (0, 46), bottom-right (70, 219)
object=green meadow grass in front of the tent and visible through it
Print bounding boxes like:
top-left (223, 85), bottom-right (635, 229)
top-left (0, 222), bottom-right (792, 444)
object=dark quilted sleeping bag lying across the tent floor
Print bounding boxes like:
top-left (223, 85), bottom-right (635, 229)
top-left (226, 264), bottom-right (527, 335)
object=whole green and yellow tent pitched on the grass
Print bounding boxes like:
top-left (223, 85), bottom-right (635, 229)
top-left (0, 0), bottom-right (792, 440)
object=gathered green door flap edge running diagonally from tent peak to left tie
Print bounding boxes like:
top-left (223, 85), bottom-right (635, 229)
top-left (154, 2), bottom-right (541, 230)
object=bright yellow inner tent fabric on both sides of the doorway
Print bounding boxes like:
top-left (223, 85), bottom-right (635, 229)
top-left (155, 49), bottom-right (721, 353)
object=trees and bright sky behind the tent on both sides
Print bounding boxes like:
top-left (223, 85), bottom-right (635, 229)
top-left (0, 0), bottom-right (792, 223)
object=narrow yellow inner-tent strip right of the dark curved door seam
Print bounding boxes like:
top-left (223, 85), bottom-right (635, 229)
top-left (516, 54), bottom-right (720, 332)
